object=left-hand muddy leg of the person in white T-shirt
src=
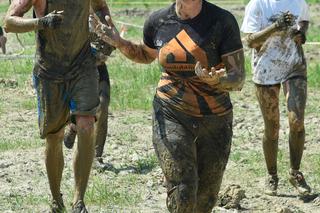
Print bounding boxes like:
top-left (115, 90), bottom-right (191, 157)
top-left (256, 85), bottom-right (280, 175)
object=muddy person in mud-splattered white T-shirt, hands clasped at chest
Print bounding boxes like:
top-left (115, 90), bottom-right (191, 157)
top-left (241, 0), bottom-right (310, 195)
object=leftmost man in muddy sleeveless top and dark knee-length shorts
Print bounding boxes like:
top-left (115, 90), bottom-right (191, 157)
top-left (4, 0), bottom-right (109, 212)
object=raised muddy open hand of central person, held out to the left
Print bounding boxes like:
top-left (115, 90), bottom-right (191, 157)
top-left (89, 14), bottom-right (121, 48)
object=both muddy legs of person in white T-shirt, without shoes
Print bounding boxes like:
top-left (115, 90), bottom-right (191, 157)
top-left (256, 77), bottom-right (307, 175)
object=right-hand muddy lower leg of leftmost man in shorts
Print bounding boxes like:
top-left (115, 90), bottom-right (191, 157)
top-left (73, 115), bottom-right (95, 204)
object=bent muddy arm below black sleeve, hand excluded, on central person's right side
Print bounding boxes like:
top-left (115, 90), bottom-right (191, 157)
top-left (215, 49), bottom-right (246, 91)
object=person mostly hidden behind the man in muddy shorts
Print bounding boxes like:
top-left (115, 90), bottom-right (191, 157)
top-left (64, 15), bottom-right (114, 170)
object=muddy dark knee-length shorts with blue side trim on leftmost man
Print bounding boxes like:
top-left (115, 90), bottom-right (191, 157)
top-left (33, 67), bottom-right (99, 139)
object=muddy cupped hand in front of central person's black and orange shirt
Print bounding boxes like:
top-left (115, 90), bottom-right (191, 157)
top-left (195, 61), bottom-right (226, 86)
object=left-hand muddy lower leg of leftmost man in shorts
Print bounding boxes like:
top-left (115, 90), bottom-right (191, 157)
top-left (45, 129), bottom-right (64, 205)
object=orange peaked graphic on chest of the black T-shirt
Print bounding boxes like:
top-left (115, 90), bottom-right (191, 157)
top-left (159, 30), bottom-right (208, 71)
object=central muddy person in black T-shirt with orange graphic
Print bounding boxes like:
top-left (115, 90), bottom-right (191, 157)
top-left (90, 0), bottom-right (245, 213)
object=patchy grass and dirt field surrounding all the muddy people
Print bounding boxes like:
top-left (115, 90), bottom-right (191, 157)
top-left (0, 0), bottom-right (320, 212)
